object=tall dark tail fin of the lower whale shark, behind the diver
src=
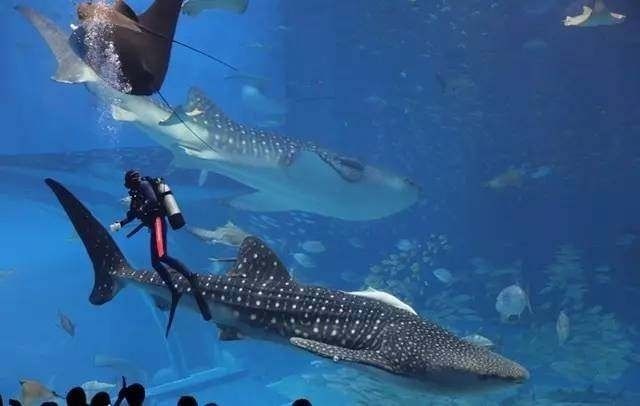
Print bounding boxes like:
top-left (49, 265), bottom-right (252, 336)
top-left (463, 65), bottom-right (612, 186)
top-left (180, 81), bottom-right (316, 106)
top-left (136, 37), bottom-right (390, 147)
top-left (45, 178), bottom-right (126, 305)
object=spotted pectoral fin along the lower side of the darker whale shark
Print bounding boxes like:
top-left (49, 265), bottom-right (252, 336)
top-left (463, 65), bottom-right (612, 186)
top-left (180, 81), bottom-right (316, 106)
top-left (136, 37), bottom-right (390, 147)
top-left (289, 337), bottom-right (397, 373)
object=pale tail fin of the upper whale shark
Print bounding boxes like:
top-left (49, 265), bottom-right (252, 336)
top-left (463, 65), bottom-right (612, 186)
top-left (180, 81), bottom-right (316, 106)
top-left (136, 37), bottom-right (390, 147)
top-left (15, 6), bottom-right (91, 83)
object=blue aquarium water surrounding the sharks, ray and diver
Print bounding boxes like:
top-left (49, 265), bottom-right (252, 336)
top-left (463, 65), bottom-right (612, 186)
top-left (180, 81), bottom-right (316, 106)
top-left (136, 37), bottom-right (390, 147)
top-left (0, 0), bottom-right (640, 405)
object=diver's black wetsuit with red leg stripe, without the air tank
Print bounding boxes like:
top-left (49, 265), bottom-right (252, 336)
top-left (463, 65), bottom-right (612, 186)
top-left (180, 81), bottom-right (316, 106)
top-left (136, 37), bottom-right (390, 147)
top-left (120, 177), bottom-right (211, 334)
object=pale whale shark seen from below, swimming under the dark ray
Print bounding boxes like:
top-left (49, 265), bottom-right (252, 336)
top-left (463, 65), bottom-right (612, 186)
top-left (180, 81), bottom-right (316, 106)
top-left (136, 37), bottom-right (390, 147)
top-left (18, 7), bottom-right (419, 221)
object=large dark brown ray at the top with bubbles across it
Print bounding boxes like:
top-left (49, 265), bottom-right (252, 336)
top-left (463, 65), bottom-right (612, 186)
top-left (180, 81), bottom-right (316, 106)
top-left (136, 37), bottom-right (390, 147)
top-left (70, 0), bottom-right (235, 96)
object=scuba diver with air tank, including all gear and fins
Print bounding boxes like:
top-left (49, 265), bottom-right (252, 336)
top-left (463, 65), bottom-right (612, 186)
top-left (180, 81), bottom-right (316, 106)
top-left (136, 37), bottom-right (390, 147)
top-left (109, 169), bottom-right (211, 336)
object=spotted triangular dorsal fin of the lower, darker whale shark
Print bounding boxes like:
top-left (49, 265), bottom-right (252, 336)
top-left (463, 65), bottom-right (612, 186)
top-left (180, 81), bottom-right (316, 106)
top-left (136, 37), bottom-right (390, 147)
top-left (227, 236), bottom-right (293, 285)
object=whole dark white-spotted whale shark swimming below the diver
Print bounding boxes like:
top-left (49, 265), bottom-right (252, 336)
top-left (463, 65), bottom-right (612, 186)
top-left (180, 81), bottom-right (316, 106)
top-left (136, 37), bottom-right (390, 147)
top-left (46, 179), bottom-right (529, 392)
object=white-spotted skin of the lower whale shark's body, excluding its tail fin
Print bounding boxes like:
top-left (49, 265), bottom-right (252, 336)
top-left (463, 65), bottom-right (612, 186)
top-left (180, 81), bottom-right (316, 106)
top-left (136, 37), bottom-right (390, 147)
top-left (112, 237), bottom-right (528, 381)
